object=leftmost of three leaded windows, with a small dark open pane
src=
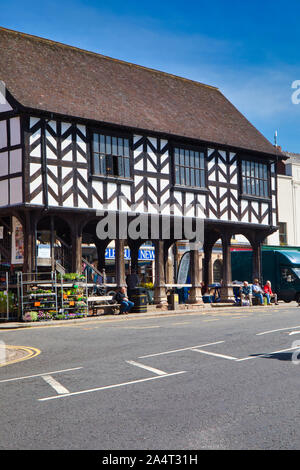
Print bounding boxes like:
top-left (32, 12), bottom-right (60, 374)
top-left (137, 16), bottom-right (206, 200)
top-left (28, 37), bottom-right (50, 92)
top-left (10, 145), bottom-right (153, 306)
top-left (93, 133), bottom-right (130, 178)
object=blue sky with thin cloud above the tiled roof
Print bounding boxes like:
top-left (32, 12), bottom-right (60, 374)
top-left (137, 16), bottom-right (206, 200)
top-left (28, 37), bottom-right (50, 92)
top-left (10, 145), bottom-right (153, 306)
top-left (0, 0), bottom-right (300, 152)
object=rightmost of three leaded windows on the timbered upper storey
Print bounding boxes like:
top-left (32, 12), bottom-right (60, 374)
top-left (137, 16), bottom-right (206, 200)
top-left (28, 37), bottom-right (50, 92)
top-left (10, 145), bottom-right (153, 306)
top-left (242, 160), bottom-right (269, 197)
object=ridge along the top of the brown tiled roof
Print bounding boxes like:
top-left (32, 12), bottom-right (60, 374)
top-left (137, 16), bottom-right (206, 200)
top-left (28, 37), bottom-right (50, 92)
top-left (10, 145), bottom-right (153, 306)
top-left (0, 26), bottom-right (221, 93)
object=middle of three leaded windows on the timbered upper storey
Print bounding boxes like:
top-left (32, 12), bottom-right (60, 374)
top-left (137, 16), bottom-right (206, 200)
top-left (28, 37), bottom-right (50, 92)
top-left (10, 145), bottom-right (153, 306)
top-left (174, 147), bottom-right (206, 188)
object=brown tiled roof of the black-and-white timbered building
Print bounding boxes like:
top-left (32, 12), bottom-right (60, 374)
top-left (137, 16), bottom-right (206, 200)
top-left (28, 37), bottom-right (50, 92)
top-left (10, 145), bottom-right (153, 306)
top-left (0, 28), bottom-right (278, 154)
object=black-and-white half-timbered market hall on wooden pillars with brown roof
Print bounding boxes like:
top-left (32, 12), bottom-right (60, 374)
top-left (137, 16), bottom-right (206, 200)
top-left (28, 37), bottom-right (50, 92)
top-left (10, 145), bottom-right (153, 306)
top-left (0, 28), bottom-right (282, 302)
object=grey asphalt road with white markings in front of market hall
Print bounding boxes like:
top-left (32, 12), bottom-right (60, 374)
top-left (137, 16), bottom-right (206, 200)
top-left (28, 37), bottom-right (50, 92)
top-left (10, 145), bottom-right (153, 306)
top-left (0, 304), bottom-right (300, 450)
